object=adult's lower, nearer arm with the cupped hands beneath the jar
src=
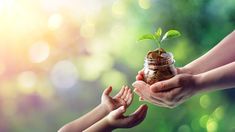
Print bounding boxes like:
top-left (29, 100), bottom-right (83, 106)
top-left (133, 62), bottom-right (235, 108)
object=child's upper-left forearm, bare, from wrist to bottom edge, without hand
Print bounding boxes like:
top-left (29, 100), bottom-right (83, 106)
top-left (59, 104), bottom-right (109, 132)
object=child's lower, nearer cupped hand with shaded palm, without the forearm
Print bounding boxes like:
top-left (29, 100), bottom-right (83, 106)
top-left (106, 105), bottom-right (148, 129)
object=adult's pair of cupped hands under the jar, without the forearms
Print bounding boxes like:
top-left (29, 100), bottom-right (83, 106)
top-left (133, 68), bottom-right (199, 108)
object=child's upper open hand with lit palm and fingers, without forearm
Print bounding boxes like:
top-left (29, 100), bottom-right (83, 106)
top-left (101, 86), bottom-right (133, 112)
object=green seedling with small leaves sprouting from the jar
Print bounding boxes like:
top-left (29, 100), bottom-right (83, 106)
top-left (138, 28), bottom-right (181, 48)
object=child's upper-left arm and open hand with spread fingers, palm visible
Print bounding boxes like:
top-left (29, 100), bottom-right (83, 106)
top-left (58, 86), bottom-right (133, 132)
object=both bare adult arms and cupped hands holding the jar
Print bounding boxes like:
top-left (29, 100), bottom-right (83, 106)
top-left (133, 31), bottom-right (235, 108)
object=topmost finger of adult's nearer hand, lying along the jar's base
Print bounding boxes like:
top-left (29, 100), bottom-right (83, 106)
top-left (150, 76), bottom-right (179, 92)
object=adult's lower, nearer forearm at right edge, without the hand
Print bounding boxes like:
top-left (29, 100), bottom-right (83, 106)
top-left (195, 62), bottom-right (235, 91)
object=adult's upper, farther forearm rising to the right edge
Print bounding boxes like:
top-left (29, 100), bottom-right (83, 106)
top-left (184, 31), bottom-right (235, 74)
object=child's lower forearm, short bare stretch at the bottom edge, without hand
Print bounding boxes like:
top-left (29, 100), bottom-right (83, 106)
top-left (84, 118), bottom-right (115, 132)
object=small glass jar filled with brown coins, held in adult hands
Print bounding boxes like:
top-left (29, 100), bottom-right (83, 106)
top-left (144, 53), bottom-right (177, 85)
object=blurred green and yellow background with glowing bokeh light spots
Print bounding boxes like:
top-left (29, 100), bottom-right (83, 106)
top-left (0, 0), bottom-right (235, 132)
